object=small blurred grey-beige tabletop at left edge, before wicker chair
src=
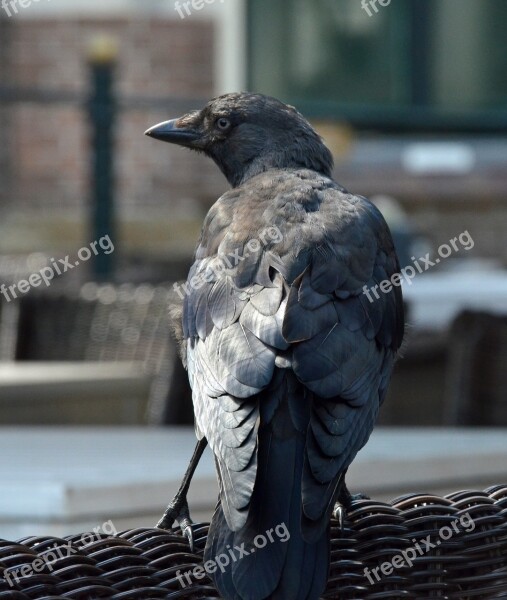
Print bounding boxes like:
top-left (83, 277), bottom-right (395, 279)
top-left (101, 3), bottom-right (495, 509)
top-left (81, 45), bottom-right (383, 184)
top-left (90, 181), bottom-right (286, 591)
top-left (0, 362), bottom-right (152, 425)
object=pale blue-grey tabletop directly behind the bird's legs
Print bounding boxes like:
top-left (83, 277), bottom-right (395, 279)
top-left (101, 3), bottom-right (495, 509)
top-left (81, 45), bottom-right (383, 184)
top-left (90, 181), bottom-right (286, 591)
top-left (0, 427), bottom-right (507, 539)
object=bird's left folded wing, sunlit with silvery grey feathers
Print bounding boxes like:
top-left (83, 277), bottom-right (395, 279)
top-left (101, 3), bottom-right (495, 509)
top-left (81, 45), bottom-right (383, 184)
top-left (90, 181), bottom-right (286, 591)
top-left (183, 190), bottom-right (289, 530)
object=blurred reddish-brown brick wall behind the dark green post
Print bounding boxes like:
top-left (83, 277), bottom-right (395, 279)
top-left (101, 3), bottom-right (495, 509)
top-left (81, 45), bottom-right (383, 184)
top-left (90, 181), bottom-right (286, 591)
top-left (0, 18), bottom-right (227, 251)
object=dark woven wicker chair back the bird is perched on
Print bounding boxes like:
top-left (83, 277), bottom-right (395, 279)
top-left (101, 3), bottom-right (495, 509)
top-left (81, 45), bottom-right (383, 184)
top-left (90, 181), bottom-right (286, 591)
top-left (0, 485), bottom-right (507, 600)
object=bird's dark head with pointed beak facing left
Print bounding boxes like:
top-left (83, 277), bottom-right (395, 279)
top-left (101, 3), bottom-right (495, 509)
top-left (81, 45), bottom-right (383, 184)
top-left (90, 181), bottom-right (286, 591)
top-left (146, 92), bottom-right (333, 187)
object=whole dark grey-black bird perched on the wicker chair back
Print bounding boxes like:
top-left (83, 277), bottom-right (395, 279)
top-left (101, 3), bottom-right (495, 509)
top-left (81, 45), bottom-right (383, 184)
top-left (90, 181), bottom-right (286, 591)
top-left (146, 92), bottom-right (404, 600)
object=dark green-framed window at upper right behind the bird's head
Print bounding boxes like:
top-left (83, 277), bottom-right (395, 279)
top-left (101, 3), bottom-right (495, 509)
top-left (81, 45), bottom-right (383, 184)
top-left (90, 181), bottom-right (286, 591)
top-left (248, 0), bottom-right (507, 130)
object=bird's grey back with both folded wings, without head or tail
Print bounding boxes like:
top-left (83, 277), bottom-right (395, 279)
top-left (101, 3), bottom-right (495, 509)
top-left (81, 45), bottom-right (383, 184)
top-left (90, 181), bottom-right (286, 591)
top-left (183, 174), bottom-right (403, 530)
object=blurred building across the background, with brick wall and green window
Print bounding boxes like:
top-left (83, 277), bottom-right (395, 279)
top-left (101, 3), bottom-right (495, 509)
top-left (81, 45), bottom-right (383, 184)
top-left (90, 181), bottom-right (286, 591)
top-left (0, 0), bottom-right (507, 258)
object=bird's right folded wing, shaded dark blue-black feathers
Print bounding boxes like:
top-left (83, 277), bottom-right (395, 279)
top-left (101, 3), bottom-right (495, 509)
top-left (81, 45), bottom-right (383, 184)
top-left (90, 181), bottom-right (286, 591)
top-left (282, 191), bottom-right (404, 539)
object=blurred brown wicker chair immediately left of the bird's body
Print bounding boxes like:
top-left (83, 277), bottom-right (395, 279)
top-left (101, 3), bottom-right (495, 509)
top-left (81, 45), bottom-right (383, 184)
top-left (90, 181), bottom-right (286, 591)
top-left (10, 282), bottom-right (193, 424)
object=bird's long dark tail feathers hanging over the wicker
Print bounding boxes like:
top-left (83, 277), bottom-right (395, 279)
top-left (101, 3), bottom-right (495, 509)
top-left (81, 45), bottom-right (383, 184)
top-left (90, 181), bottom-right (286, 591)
top-left (204, 376), bottom-right (329, 600)
